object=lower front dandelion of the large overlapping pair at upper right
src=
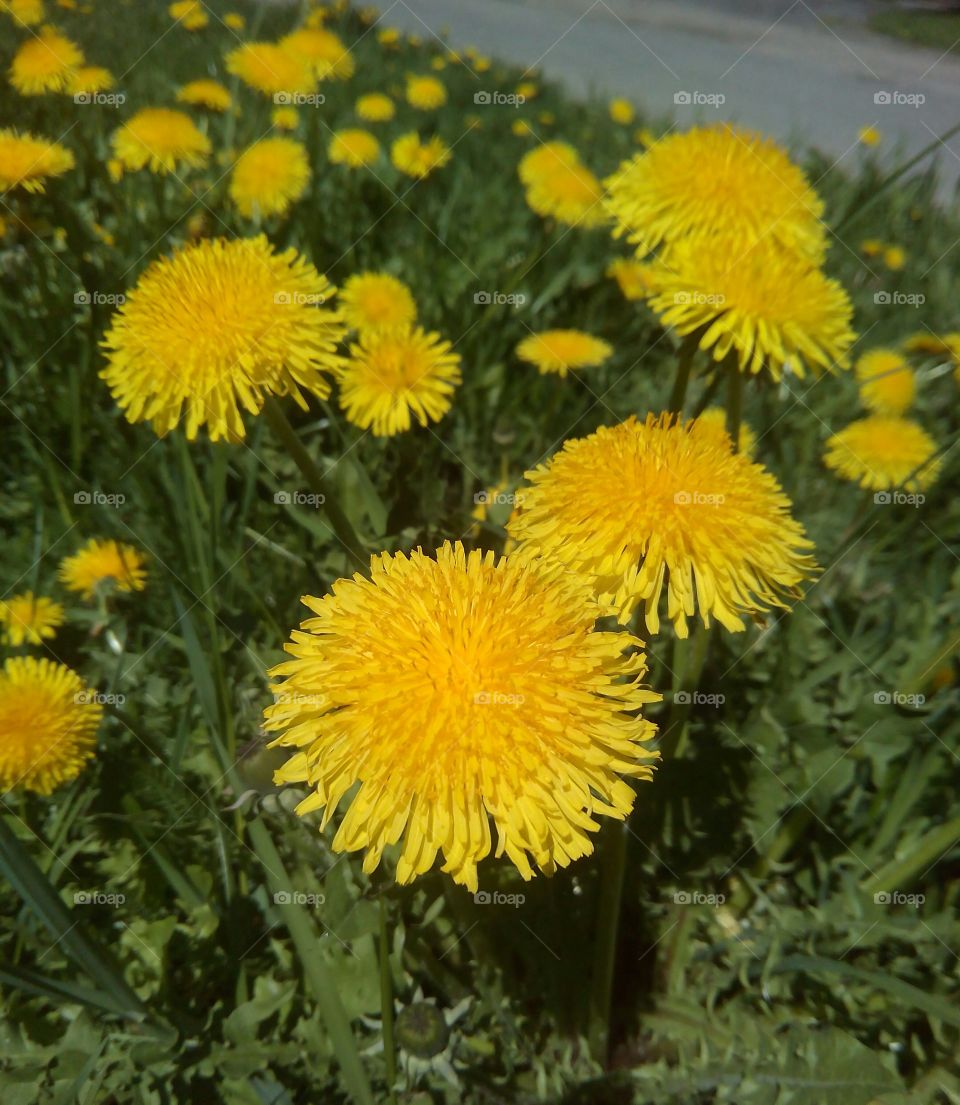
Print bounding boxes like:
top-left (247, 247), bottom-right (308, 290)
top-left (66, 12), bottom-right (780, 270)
top-left (647, 235), bottom-right (855, 379)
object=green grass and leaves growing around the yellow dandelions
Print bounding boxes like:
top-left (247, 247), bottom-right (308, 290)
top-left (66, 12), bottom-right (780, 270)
top-left (0, 0), bottom-right (960, 1105)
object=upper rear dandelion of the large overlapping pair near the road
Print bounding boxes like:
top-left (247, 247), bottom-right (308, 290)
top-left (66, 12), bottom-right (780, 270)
top-left (606, 126), bottom-right (826, 261)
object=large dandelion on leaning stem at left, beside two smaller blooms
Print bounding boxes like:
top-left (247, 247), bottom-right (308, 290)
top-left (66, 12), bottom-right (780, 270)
top-left (101, 234), bottom-right (345, 442)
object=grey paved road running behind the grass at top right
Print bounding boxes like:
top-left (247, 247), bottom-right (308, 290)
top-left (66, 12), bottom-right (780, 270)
top-left (373, 0), bottom-right (960, 198)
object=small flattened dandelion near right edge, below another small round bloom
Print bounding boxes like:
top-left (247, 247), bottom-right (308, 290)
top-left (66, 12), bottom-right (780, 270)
top-left (823, 414), bottom-right (942, 492)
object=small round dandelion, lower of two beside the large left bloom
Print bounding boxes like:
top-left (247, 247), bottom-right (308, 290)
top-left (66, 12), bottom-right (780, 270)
top-left (338, 325), bottom-right (461, 438)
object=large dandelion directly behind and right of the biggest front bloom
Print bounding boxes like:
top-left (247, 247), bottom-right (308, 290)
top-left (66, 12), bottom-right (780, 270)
top-left (508, 414), bottom-right (815, 636)
